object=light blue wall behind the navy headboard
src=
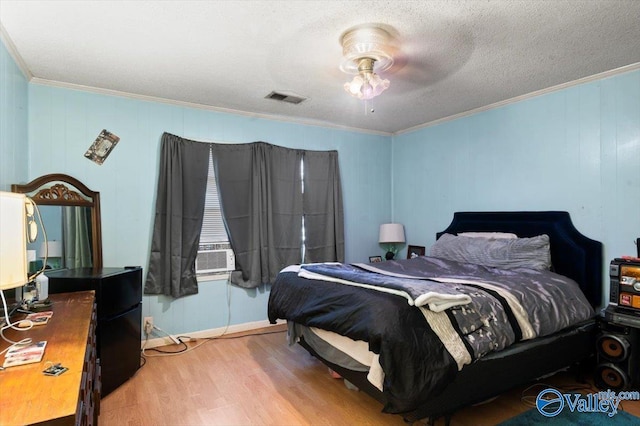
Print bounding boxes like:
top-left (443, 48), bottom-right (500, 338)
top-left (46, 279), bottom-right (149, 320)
top-left (392, 71), bottom-right (640, 302)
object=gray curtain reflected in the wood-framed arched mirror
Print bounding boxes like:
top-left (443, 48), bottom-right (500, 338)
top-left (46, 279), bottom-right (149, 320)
top-left (62, 206), bottom-right (93, 269)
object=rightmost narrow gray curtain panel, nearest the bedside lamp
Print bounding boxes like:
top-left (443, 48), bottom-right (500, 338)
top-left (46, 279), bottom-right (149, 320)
top-left (303, 151), bottom-right (344, 263)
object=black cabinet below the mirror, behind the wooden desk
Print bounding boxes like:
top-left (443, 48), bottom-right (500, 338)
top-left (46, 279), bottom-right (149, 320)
top-left (46, 267), bottom-right (142, 396)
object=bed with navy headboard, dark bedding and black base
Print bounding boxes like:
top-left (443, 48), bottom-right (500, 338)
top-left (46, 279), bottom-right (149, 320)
top-left (268, 211), bottom-right (603, 423)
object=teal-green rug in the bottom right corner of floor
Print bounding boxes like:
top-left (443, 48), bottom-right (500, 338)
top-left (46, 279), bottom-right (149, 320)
top-left (500, 407), bottom-right (640, 426)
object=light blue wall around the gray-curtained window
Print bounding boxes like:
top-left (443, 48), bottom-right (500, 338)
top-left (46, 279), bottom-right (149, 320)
top-left (29, 84), bottom-right (391, 334)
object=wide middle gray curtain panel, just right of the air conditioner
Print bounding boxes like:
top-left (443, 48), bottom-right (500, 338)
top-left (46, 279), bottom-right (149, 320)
top-left (211, 142), bottom-right (303, 288)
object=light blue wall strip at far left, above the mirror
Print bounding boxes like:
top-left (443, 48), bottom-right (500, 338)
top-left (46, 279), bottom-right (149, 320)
top-left (0, 38), bottom-right (29, 191)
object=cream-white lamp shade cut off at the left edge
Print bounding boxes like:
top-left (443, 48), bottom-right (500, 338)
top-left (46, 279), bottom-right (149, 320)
top-left (0, 192), bottom-right (28, 290)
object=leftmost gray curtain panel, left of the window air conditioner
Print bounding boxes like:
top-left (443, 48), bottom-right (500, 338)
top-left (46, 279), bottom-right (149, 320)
top-left (144, 133), bottom-right (210, 297)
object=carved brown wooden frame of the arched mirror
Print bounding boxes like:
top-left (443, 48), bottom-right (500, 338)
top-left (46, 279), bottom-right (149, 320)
top-left (11, 173), bottom-right (102, 269)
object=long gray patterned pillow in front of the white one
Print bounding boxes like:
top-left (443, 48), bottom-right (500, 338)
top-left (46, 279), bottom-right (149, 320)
top-left (430, 234), bottom-right (551, 270)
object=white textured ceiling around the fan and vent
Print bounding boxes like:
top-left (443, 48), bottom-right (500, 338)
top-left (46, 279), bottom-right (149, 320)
top-left (0, 0), bottom-right (640, 133)
